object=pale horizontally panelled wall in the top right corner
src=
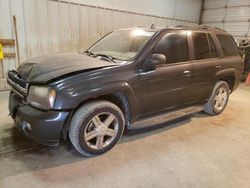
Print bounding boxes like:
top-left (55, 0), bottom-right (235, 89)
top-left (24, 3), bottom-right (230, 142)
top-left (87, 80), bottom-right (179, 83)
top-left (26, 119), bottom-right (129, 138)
top-left (202, 0), bottom-right (250, 39)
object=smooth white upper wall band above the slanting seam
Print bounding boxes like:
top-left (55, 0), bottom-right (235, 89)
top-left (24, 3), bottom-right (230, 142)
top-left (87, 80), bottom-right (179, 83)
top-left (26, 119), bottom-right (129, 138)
top-left (70, 0), bottom-right (201, 22)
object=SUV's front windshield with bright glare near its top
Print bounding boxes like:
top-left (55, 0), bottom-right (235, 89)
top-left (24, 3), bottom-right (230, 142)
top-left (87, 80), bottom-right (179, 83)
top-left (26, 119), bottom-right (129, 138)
top-left (88, 29), bottom-right (155, 60)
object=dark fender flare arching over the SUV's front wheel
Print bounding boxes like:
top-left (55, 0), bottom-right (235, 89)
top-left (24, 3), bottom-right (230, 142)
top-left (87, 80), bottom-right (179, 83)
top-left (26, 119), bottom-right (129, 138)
top-left (54, 82), bottom-right (138, 118)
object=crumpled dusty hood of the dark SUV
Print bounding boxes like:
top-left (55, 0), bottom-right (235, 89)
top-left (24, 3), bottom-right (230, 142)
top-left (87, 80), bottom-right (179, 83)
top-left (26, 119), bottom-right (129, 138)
top-left (18, 53), bottom-right (116, 83)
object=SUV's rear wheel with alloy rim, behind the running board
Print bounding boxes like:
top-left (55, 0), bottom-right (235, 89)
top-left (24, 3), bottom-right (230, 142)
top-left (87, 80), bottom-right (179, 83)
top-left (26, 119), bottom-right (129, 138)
top-left (204, 81), bottom-right (230, 115)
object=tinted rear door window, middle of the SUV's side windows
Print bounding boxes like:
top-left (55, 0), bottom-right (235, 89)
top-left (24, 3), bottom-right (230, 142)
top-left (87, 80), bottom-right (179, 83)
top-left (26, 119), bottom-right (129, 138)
top-left (192, 32), bottom-right (210, 60)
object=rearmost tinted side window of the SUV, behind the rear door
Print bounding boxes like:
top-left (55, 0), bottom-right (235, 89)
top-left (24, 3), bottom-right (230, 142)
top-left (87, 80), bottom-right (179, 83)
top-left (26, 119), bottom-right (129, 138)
top-left (216, 35), bottom-right (239, 56)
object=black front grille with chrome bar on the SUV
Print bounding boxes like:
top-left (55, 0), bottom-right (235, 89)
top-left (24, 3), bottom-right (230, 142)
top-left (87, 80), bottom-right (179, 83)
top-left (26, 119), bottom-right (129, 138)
top-left (7, 70), bottom-right (28, 97)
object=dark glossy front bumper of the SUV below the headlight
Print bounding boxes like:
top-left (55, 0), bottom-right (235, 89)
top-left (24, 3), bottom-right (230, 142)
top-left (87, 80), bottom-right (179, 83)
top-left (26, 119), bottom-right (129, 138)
top-left (9, 92), bottom-right (69, 146)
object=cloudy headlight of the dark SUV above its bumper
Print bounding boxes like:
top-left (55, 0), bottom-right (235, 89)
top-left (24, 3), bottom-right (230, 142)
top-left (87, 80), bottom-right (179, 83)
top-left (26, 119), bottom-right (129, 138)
top-left (27, 86), bottom-right (56, 110)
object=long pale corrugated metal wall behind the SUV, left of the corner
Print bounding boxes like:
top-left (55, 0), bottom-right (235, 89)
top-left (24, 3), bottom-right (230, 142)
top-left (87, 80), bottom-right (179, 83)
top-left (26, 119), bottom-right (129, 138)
top-left (0, 0), bottom-right (201, 89)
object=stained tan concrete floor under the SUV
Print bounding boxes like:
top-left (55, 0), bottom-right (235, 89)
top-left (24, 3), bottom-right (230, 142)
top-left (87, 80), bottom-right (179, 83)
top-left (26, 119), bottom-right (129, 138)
top-left (0, 85), bottom-right (250, 188)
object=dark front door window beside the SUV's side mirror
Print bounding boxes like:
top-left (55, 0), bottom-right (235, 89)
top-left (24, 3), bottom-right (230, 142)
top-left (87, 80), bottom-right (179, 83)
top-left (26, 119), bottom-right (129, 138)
top-left (153, 33), bottom-right (189, 63)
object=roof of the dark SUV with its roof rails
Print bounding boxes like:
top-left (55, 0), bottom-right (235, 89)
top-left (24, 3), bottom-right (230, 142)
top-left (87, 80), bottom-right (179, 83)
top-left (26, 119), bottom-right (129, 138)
top-left (118, 25), bottom-right (228, 35)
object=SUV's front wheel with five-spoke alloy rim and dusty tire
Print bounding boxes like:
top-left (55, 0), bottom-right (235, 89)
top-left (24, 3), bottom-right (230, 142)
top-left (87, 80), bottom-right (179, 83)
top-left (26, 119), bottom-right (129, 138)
top-left (69, 100), bottom-right (125, 157)
